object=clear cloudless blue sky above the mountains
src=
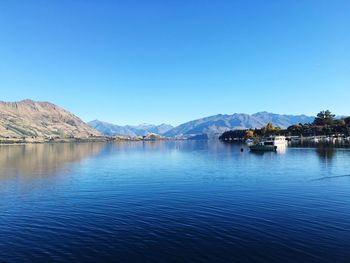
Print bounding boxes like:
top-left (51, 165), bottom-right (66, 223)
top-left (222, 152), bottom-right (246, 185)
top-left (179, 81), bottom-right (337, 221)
top-left (0, 0), bottom-right (350, 124)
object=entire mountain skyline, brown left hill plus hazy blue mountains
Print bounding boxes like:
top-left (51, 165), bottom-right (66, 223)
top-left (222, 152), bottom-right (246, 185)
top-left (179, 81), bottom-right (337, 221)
top-left (0, 100), bottom-right (314, 138)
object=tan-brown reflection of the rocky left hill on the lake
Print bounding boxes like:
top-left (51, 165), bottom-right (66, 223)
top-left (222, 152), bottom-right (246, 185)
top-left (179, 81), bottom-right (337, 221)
top-left (0, 143), bottom-right (106, 179)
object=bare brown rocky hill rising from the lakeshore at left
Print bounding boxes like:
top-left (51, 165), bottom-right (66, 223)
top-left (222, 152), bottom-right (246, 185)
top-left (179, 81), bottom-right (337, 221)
top-left (0, 100), bottom-right (100, 138)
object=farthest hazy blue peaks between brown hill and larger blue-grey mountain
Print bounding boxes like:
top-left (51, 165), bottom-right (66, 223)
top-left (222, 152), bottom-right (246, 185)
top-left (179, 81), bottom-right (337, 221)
top-left (88, 120), bottom-right (174, 136)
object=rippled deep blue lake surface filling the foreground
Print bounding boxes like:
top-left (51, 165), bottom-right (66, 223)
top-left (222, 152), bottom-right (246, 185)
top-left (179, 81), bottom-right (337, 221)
top-left (0, 141), bottom-right (350, 263)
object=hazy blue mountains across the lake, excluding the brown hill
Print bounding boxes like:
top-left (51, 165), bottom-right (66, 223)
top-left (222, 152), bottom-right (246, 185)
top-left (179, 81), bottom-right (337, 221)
top-left (88, 112), bottom-right (314, 138)
